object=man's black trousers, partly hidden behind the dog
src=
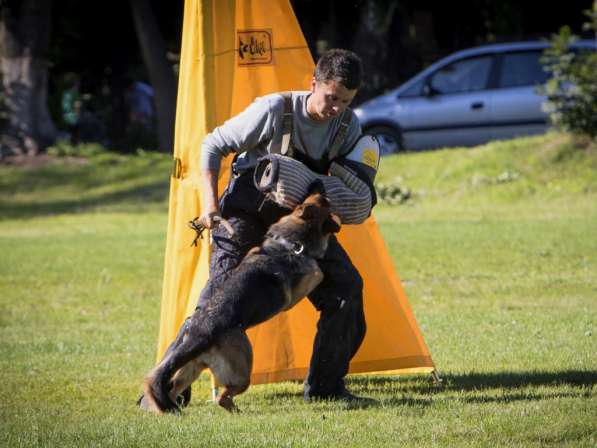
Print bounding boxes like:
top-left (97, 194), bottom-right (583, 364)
top-left (174, 171), bottom-right (366, 398)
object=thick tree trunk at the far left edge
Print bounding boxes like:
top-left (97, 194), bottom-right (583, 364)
top-left (0, 0), bottom-right (56, 155)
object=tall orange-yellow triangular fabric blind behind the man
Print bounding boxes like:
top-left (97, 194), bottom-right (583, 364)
top-left (158, 0), bottom-right (434, 384)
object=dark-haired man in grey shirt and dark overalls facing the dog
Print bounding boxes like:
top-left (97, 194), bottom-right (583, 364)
top-left (196, 50), bottom-right (372, 401)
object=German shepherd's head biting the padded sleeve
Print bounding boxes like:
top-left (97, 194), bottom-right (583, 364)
top-left (268, 184), bottom-right (341, 258)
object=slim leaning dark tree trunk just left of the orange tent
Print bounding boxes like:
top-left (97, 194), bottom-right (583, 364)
top-left (130, 0), bottom-right (176, 152)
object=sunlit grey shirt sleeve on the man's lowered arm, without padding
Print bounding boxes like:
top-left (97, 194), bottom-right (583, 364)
top-left (200, 95), bottom-right (274, 171)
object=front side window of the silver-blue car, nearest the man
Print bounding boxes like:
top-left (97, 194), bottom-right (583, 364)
top-left (431, 56), bottom-right (492, 93)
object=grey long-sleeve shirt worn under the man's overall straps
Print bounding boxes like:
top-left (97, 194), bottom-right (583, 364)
top-left (200, 91), bottom-right (361, 172)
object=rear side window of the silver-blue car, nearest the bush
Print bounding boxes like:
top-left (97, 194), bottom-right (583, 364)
top-left (498, 51), bottom-right (549, 88)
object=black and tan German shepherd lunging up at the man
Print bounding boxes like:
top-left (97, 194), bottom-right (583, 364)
top-left (140, 184), bottom-right (340, 414)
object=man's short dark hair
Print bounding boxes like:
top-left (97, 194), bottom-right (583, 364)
top-left (315, 48), bottom-right (363, 90)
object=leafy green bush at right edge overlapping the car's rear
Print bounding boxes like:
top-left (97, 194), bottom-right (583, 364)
top-left (541, 1), bottom-right (597, 139)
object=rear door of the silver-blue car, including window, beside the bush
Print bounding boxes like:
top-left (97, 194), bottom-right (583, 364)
top-left (491, 50), bottom-right (549, 139)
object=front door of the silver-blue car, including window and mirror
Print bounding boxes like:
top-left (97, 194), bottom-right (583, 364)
top-left (401, 54), bottom-right (494, 149)
